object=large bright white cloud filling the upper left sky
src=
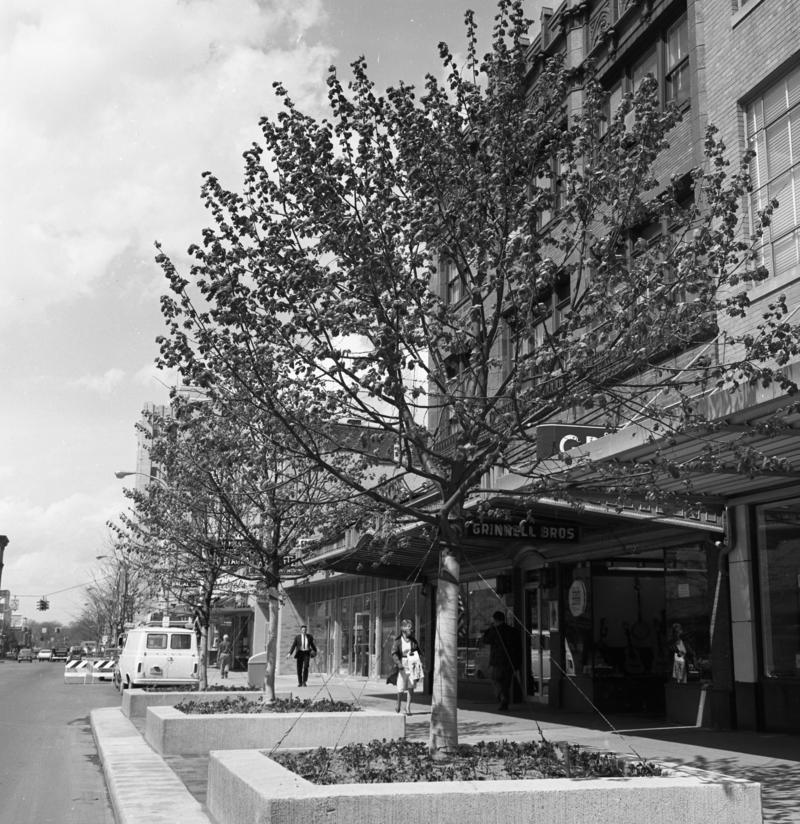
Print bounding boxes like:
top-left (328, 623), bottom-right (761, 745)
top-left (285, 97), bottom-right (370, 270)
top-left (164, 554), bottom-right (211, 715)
top-left (0, 0), bottom-right (331, 311)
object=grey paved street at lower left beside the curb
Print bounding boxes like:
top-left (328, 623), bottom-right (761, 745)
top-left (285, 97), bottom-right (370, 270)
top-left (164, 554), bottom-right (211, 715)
top-left (0, 661), bottom-right (119, 824)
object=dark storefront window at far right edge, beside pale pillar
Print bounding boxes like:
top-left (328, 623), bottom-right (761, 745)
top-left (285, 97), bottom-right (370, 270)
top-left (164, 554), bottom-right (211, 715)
top-left (758, 500), bottom-right (800, 678)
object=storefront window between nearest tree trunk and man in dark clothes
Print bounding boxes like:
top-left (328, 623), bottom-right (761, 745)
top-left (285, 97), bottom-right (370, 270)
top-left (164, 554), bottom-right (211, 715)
top-left (458, 578), bottom-right (510, 678)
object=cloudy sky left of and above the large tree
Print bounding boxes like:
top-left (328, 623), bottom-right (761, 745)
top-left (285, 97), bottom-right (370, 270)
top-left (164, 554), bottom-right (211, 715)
top-left (0, 0), bottom-right (558, 625)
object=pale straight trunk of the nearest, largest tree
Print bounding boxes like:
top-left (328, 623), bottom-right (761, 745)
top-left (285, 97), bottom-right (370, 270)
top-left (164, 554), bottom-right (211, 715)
top-left (429, 541), bottom-right (461, 753)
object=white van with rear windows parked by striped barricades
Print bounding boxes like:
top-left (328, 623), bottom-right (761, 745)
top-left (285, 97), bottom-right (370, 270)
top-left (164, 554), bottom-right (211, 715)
top-left (114, 620), bottom-right (198, 689)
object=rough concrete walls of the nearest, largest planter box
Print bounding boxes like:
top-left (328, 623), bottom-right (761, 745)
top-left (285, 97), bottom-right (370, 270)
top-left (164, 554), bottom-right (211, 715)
top-left (206, 750), bottom-right (762, 824)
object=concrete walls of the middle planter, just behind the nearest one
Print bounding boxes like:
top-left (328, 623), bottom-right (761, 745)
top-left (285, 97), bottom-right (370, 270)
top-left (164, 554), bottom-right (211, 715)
top-left (145, 707), bottom-right (406, 755)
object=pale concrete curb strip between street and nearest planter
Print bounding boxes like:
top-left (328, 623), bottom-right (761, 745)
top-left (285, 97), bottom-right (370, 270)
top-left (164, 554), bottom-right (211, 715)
top-left (90, 707), bottom-right (212, 824)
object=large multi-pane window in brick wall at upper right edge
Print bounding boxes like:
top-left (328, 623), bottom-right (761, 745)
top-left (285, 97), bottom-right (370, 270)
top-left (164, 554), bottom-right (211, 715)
top-left (745, 63), bottom-right (800, 276)
